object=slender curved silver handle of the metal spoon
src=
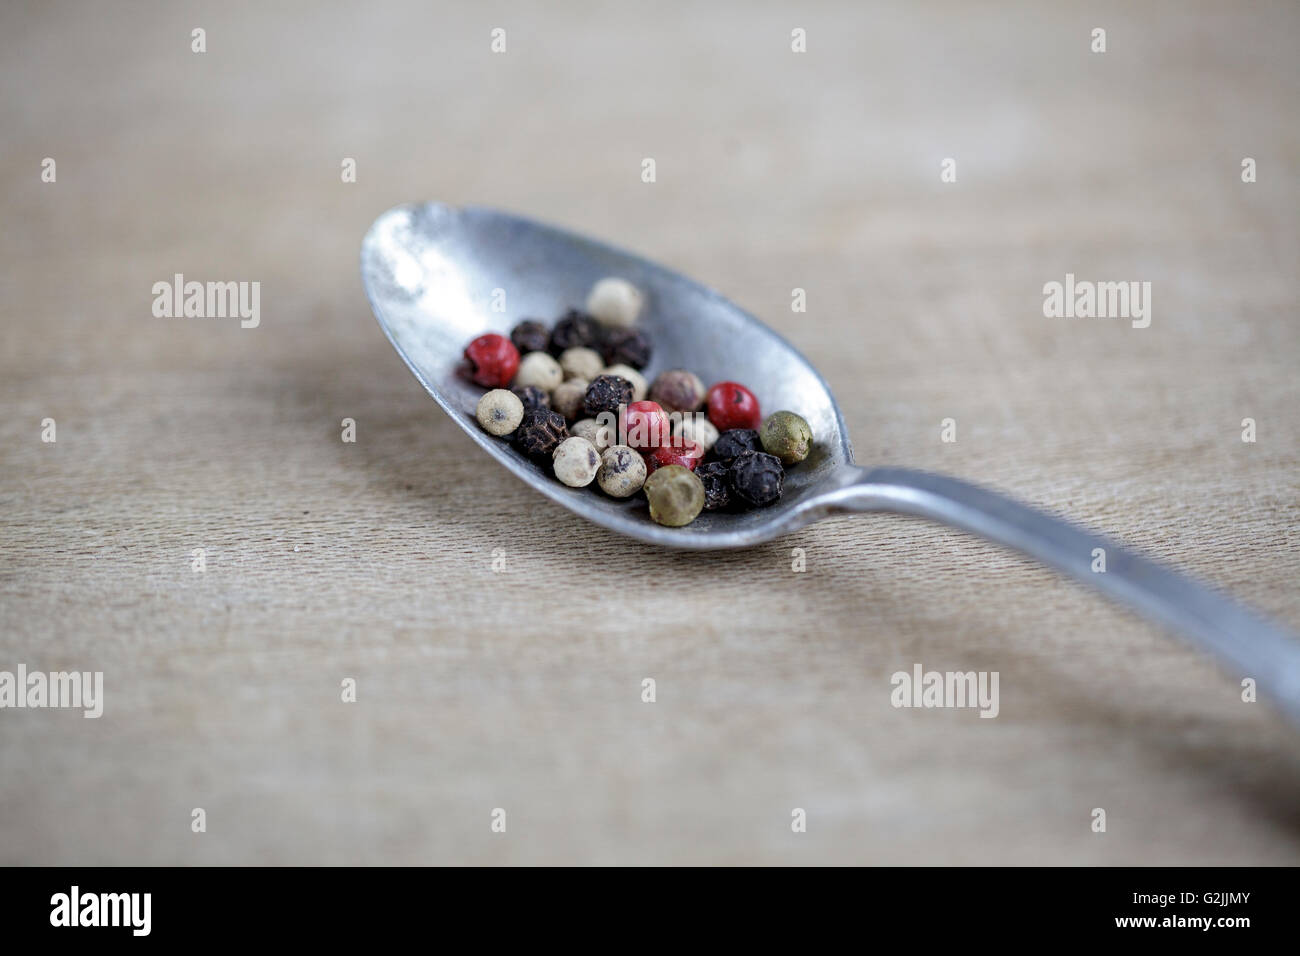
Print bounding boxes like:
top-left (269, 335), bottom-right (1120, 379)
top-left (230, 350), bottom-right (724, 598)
top-left (826, 468), bottom-right (1300, 726)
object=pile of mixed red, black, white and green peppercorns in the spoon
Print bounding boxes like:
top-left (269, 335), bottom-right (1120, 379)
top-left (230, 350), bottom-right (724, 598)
top-left (465, 278), bottom-right (813, 527)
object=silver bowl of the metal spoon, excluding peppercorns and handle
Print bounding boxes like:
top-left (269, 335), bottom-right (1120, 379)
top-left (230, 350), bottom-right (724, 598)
top-left (361, 203), bottom-right (853, 549)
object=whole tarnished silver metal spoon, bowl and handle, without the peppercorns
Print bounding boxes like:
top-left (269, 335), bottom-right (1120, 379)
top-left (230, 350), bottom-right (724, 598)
top-left (361, 203), bottom-right (1300, 724)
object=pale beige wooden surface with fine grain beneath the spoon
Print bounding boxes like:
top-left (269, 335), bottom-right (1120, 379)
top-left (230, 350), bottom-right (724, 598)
top-left (0, 3), bottom-right (1300, 864)
